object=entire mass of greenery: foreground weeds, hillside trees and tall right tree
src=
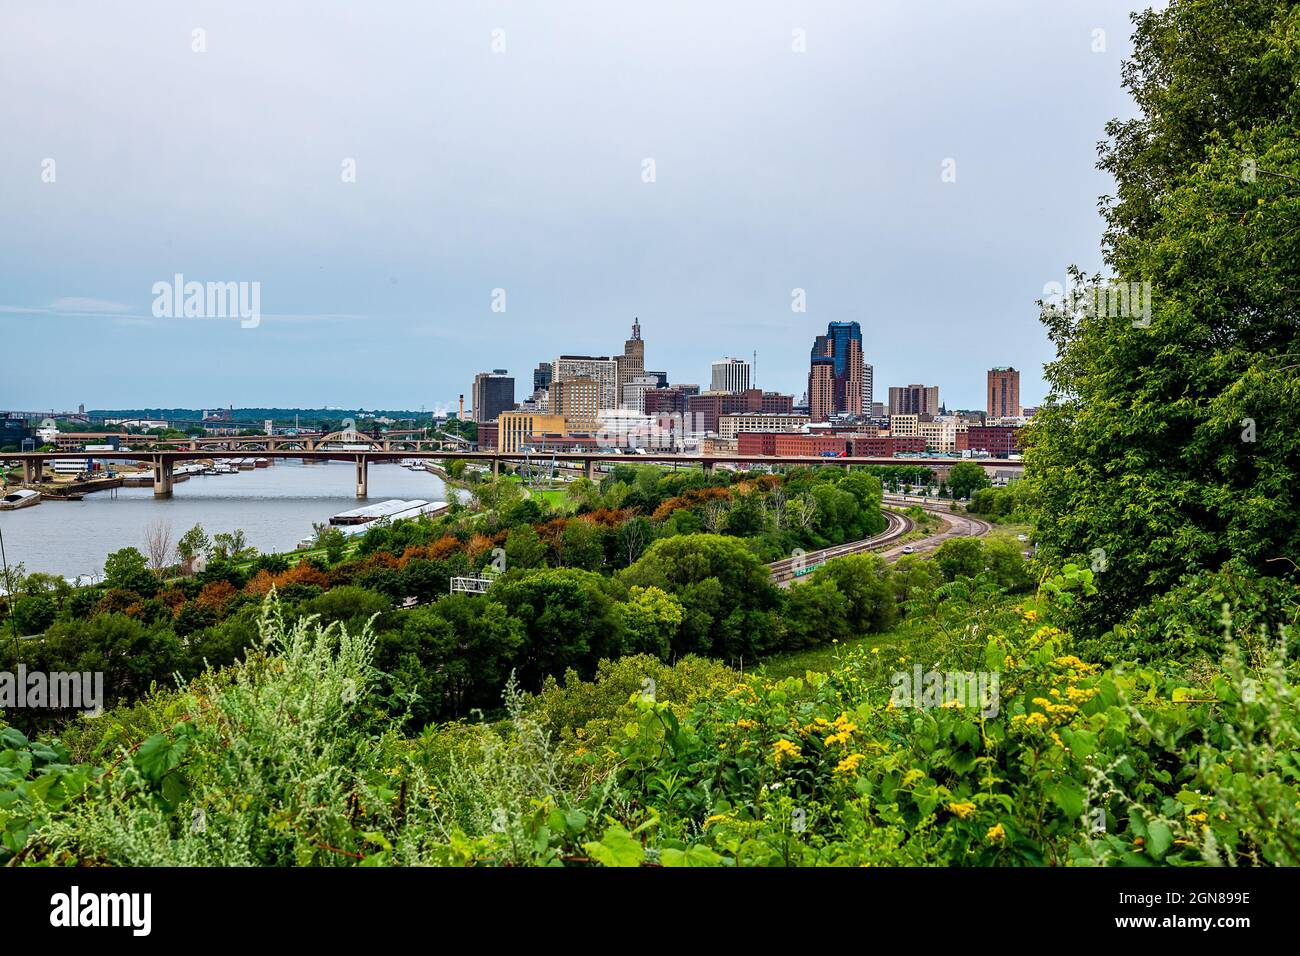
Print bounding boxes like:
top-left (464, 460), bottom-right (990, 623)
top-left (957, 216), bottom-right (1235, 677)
top-left (0, 0), bottom-right (1300, 866)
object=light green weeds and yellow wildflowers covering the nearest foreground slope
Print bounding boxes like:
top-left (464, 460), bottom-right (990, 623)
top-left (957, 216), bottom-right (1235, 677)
top-left (0, 568), bottom-right (1300, 866)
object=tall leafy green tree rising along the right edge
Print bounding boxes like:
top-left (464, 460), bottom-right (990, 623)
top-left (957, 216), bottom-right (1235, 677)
top-left (1026, 0), bottom-right (1300, 630)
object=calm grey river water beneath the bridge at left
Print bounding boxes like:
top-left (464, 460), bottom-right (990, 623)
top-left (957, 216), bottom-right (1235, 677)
top-left (0, 459), bottom-right (457, 578)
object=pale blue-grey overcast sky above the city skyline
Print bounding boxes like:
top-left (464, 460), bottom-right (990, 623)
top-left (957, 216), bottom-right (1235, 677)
top-left (0, 0), bottom-right (1135, 410)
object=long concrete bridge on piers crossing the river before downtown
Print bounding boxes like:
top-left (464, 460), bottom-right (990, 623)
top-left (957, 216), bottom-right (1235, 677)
top-left (0, 450), bottom-right (1024, 498)
